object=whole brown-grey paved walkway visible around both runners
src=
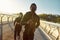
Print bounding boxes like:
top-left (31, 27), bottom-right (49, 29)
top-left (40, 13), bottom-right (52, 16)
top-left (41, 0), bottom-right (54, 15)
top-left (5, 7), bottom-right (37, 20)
top-left (0, 24), bottom-right (49, 40)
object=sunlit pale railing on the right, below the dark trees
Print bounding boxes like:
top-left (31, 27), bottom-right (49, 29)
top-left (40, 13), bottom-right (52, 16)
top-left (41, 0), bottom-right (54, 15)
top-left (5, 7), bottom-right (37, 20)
top-left (40, 20), bottom-right (60, 40)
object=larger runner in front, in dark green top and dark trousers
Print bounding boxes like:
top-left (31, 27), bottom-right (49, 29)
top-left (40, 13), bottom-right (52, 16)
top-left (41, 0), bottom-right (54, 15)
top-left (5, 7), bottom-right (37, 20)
top-left (22, 3), bottom-right (40, 40)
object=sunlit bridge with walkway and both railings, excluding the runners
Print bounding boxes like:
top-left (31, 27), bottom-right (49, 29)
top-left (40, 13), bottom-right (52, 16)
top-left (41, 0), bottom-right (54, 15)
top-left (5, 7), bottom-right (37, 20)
top-left (0, 14), bottom-right (60, 40)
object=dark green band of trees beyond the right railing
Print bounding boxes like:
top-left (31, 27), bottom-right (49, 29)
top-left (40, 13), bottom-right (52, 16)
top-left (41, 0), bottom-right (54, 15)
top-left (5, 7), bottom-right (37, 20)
top-left (39, 14), bottom-right (60, 23)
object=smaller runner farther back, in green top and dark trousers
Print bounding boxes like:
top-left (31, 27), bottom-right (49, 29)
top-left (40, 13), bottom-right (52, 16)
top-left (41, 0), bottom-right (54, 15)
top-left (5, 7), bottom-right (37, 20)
top-left (14, 13), bottom-right (23, 40)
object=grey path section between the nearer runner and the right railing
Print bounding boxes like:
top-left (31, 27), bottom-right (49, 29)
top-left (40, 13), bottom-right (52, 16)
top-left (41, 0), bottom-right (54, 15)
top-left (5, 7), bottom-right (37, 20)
top-left (34, 28), bottom-right (49, 40)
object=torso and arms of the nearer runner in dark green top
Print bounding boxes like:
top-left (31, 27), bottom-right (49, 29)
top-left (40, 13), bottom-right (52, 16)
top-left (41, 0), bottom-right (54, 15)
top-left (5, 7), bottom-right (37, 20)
top-left (22, 12), bottom-right (40, 31)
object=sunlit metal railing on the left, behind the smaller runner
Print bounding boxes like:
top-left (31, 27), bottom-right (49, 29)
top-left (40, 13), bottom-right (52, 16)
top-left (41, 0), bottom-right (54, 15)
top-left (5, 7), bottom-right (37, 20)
top-left (0, 14), bottom-right (17, 40)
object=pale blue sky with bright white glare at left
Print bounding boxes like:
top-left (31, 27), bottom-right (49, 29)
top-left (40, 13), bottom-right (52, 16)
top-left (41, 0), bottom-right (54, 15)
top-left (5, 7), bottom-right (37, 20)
top-left (0, 0), bottom-right (60, 15)
